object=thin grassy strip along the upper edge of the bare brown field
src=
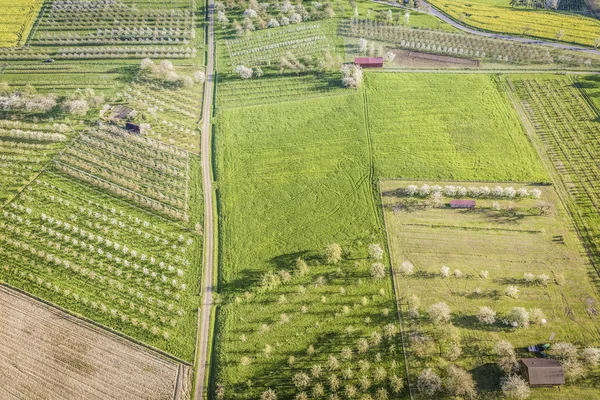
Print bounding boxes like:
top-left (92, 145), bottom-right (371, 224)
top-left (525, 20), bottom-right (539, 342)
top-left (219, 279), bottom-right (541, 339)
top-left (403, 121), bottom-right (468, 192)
top-left (0, 282), bottom-right (192, 366)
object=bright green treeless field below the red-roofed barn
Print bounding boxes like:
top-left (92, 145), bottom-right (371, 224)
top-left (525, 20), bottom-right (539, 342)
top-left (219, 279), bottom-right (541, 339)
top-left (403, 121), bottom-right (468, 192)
top-left (365, 73), bottom-right (548, 182)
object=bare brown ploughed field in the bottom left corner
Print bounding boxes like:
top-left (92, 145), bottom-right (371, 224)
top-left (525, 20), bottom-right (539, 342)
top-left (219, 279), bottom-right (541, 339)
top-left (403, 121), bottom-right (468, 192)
top-left (0, 286), bottom-right (190, 400)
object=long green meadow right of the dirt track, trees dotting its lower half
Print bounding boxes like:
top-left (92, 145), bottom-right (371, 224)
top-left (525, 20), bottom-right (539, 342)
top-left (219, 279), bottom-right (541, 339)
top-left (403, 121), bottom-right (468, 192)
top-left (214, 95), bottom-right (402, 399)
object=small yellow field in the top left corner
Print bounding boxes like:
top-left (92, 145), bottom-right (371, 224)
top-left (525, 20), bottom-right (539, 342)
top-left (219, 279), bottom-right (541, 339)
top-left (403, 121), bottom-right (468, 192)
top-left (0, 0), bottom-right (43, 47)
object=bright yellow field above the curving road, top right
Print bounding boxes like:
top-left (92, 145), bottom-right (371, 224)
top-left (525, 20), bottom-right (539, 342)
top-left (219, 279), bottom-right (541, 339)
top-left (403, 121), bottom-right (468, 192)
top-left (430, 0), bottom-right (600, 46)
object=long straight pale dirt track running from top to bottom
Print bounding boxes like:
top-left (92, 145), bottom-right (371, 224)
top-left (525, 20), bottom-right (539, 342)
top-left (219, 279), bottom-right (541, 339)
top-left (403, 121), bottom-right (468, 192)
top-left (194, 0), bottom-right (215, 400)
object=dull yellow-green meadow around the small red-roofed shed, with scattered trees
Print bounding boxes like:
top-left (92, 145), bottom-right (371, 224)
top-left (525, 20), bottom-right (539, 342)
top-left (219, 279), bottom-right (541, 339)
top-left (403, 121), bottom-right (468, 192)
top-left (381, 181), bottom-right (600, 399)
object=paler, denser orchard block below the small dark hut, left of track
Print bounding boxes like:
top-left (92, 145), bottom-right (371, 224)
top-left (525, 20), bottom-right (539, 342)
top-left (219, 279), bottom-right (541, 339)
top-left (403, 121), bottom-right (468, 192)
top-left (57, 127), bottom-right (189, 219)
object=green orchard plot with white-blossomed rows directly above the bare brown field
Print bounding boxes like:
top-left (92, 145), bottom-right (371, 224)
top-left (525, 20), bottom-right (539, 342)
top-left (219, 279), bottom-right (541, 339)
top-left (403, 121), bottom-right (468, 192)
top-left (0, 174), bottom-right (197, 357)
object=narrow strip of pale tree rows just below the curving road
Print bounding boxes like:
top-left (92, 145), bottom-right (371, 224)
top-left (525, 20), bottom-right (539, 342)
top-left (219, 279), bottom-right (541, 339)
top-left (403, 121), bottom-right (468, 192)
top-left (341, 19), bottom-right (598, 65)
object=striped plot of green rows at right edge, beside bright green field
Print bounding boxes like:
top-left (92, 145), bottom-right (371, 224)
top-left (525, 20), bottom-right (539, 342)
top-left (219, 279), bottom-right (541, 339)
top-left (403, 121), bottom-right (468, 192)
top-left (509, 78), bottom-right (600, 268)
